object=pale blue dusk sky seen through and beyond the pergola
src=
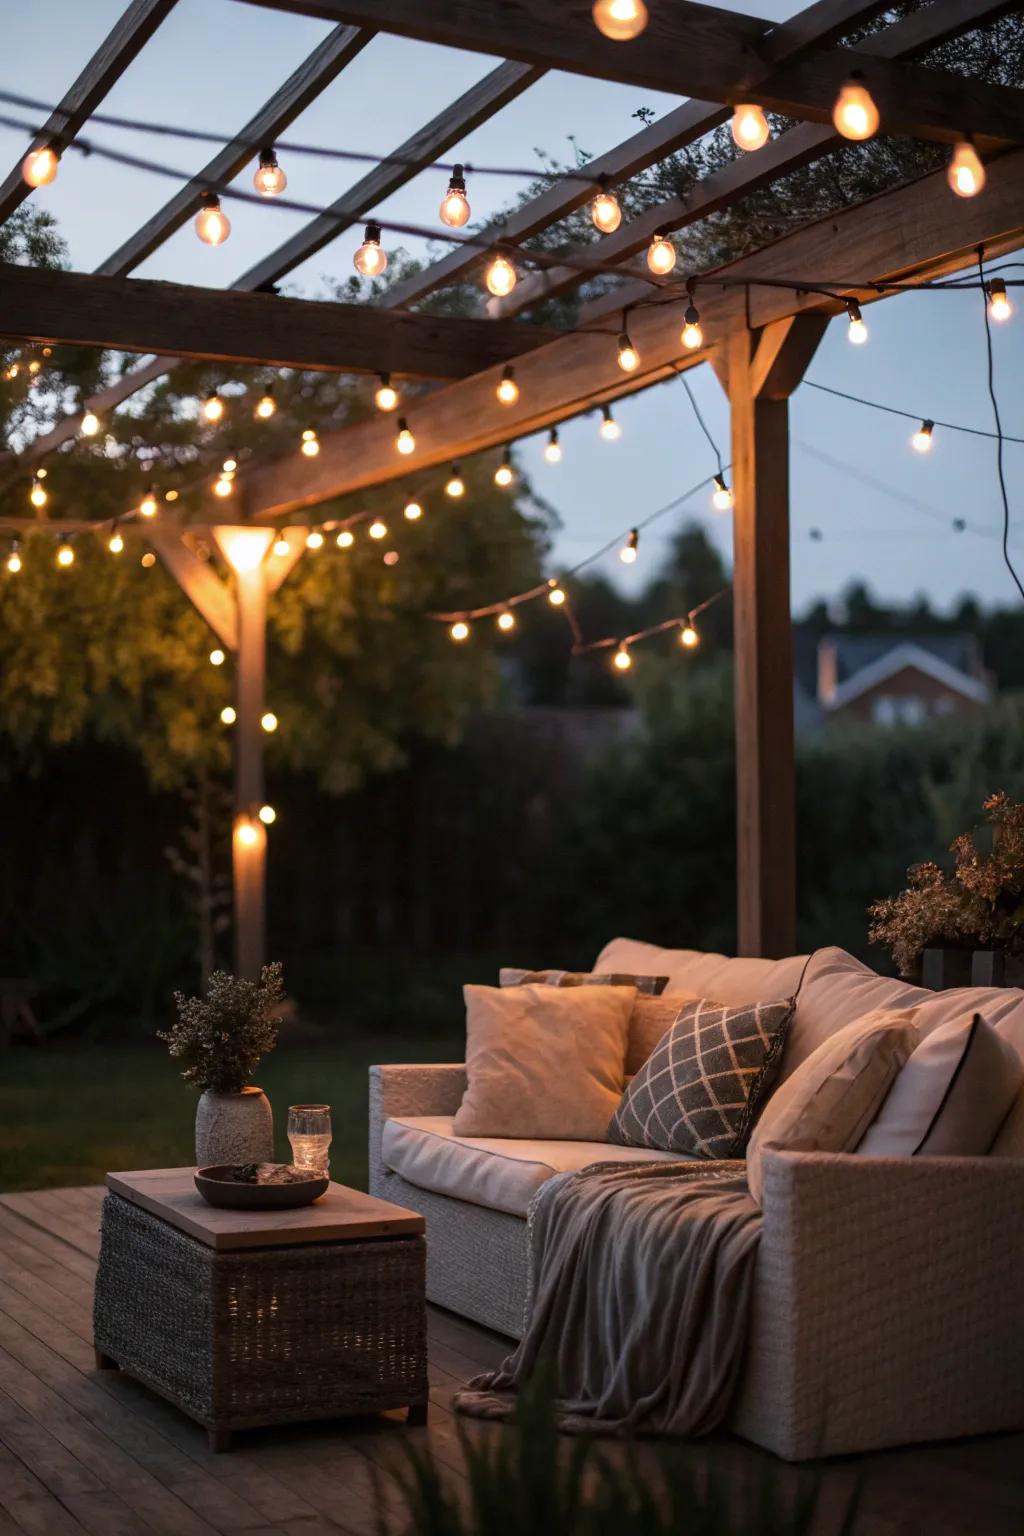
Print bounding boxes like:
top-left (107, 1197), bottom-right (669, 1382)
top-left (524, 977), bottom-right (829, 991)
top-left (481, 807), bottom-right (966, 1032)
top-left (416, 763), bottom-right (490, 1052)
top-left (0, 0), bottom-right (1024, 610)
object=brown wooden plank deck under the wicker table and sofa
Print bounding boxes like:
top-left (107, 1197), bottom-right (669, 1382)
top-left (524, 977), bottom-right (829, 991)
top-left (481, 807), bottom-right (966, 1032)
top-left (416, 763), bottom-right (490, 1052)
top-left (0, 1189), bottom-right (1024, 1536)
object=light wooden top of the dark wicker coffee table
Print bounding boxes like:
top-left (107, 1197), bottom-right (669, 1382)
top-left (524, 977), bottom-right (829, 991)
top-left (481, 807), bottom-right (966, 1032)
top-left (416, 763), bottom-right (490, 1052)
top-left (106, 1167), bottom-right (427, 1250)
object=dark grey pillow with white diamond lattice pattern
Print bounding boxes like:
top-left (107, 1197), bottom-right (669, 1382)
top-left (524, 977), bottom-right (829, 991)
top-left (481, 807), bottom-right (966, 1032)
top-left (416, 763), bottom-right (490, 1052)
top-left (608, 997), bottom-right (794, 1158)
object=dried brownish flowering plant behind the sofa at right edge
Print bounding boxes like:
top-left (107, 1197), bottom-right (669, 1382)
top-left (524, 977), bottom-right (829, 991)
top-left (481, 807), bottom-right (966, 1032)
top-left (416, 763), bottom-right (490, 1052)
top-left (867, 793), bottom-right (1024, 975)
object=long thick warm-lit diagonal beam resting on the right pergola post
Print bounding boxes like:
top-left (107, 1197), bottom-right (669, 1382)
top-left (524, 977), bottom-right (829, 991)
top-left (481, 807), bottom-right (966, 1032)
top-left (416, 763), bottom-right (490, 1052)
top-left (243, 151), bottom-right (1024, 516)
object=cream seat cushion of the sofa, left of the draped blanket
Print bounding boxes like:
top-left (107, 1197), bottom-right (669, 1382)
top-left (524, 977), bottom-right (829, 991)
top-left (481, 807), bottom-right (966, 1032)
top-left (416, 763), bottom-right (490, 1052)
top-left (381, 1115), bottom-right (689, 1217)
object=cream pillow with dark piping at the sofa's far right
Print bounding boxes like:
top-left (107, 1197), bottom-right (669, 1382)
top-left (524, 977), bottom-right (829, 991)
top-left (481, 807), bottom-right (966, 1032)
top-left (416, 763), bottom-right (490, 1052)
top-left (857, 1014), bottom-right (1024, 1157)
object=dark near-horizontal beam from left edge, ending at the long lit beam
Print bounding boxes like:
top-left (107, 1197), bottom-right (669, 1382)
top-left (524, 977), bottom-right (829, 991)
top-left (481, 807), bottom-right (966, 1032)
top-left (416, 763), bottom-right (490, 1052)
top-left (0, 266), bottom-right (556, 376)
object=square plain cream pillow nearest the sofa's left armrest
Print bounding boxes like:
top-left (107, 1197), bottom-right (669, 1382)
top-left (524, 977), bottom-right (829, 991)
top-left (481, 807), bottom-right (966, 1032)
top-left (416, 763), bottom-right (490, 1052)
top-left (453, 985), bottom-right (637, 1141)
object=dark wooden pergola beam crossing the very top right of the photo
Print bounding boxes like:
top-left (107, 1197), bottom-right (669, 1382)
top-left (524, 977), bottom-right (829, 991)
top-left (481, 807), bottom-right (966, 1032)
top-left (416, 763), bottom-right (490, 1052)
top-left (242, 0), bottom-right (1024, 143)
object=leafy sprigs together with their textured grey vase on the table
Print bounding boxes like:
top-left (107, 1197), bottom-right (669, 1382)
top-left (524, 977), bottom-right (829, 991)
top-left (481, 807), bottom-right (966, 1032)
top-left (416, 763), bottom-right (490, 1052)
top-left (160, 962), bottom-right (284, 1167)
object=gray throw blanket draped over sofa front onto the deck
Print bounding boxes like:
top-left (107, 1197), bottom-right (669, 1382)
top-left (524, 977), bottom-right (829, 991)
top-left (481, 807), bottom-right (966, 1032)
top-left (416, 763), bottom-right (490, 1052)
top-left (454, 1163), bottom-right (761, 1435)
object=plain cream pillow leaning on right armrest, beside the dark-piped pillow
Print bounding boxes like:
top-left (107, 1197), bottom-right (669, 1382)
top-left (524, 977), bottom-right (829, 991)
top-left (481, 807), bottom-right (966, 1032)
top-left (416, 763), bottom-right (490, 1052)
top-left (746, 1008), bottom-right (918, 1204)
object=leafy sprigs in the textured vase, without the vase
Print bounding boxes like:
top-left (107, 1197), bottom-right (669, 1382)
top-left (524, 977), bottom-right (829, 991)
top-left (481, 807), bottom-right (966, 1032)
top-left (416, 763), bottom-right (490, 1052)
top-left (160, 962), bottom-right (284, 1094)
